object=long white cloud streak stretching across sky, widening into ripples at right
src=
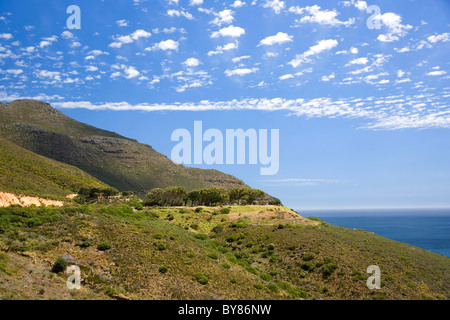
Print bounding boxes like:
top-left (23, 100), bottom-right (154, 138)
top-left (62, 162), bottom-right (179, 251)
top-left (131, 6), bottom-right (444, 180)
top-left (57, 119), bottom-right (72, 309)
top-left (49, 93), bottom-right (450, 130)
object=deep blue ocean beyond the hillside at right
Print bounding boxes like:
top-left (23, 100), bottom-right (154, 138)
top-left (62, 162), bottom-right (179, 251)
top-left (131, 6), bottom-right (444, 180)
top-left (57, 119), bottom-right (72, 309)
top-left (298, 209), bottom-right (450, 257)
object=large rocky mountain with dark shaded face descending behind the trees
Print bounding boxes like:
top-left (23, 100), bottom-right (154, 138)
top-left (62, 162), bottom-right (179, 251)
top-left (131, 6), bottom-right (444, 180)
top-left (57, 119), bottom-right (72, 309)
top-left (0, 100), bottom-right (247, 193)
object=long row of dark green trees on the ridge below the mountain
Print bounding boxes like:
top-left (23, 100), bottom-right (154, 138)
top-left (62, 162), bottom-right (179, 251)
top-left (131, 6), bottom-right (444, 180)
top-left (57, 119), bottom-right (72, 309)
top-left (145, 187), bottom-right (281, 206)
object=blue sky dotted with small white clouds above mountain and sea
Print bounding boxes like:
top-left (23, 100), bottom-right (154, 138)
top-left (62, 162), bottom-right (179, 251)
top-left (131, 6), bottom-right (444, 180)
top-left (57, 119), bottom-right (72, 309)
top-left (0, 0), bottom-right (450, 209)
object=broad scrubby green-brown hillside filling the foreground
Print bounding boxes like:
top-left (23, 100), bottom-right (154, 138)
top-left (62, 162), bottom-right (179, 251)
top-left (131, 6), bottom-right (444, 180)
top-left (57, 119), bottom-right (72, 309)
top-left (0, 205), bottom-right (450, 299)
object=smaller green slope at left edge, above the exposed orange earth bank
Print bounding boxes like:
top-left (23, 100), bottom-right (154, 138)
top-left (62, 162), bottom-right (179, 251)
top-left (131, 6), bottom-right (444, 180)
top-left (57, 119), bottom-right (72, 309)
top-left (0, 137), bottom-right (107, 198)
